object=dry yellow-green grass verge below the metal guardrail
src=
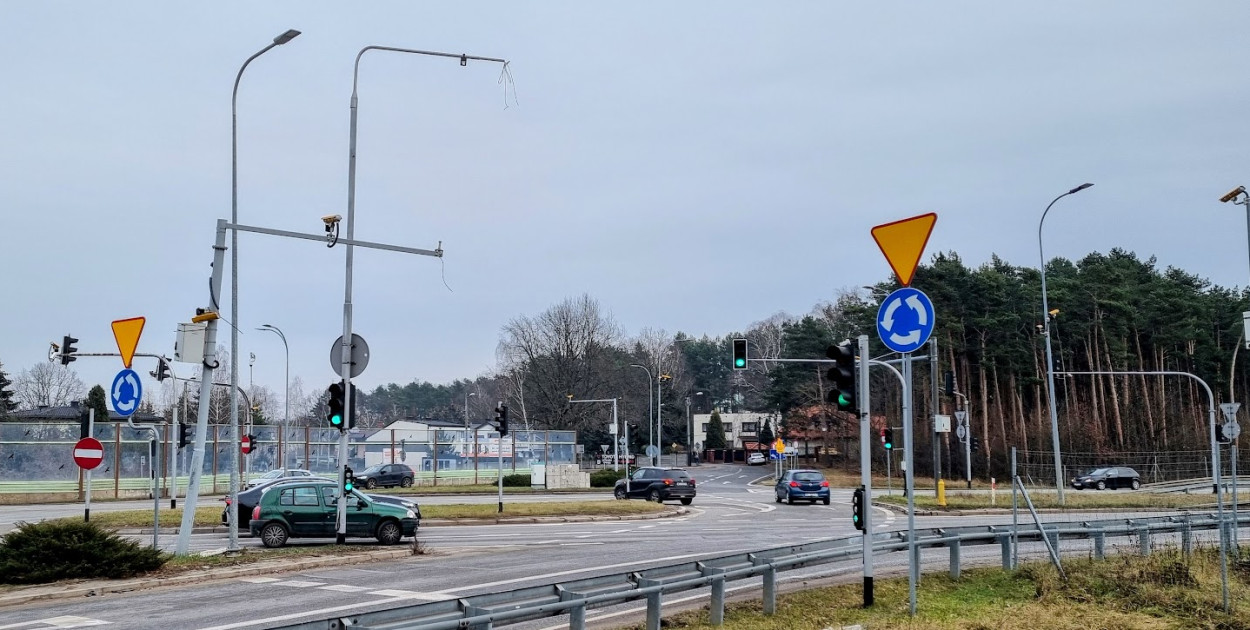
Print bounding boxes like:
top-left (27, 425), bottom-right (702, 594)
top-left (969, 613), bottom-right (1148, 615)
top-left (635, 549), bottom-right (1250, 630)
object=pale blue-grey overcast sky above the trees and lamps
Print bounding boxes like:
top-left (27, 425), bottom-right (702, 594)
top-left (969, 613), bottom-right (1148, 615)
top-left (0, 0), bottom-right (1250, 405)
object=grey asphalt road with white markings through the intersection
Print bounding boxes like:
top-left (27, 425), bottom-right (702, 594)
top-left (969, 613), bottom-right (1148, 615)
top-left (0, 465), bottom-right (1240, 630)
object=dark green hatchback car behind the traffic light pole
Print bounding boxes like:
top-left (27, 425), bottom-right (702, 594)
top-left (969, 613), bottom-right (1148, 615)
top-left (249, 481), bottom-right (420, 548)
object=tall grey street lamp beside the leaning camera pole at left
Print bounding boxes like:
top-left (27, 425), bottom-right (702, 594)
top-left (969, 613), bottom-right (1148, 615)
top-left (228, 29), bottom-right (300, 549)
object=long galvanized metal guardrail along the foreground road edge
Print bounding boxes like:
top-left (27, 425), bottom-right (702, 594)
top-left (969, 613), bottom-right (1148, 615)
top-left (279, 514), bottom-right (1250, 630)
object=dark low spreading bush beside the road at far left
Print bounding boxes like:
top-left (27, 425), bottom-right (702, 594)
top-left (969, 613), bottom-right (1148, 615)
top-left (0, 521), bottom-right (170, 584)
